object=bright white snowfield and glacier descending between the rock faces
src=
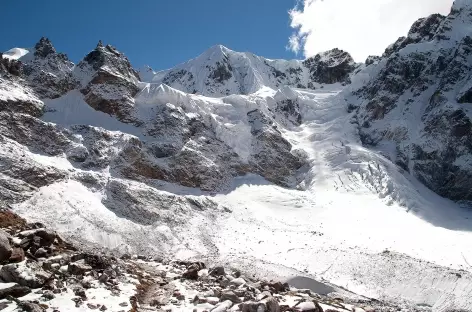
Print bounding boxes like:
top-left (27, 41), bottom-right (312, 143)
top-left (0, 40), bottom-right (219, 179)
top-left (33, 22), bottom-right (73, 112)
top-left (10, 84), bottom-right (472, 311)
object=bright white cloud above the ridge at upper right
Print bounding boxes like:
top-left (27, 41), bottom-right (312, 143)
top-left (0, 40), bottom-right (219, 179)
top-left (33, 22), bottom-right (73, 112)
top-left (288, 0), bottom-right (453, 62)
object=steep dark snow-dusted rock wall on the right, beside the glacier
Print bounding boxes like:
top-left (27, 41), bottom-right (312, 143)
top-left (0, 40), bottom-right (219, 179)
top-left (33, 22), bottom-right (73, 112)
top-left (349, 4), bottom-right (472, 200)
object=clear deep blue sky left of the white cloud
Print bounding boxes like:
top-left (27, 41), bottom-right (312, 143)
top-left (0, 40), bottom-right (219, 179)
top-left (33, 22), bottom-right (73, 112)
top-left (0, 0), bottom-right (296, 69)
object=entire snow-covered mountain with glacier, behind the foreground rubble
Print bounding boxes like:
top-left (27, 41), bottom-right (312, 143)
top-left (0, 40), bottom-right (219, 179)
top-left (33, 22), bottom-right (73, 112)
top-left (0, 0), bottom-right (472, 311)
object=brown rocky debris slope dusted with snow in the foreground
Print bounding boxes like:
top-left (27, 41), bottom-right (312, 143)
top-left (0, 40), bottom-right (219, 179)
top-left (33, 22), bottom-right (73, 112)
top-left (0, 210), bottom-right (426, 312)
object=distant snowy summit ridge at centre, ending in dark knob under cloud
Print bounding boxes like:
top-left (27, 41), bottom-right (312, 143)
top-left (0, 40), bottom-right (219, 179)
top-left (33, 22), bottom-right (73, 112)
top-left (140, 45), bottom-right (356, 97)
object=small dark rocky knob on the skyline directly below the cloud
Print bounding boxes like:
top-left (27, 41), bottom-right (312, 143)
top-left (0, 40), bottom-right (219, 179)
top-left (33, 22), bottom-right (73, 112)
top-left (303, 49), bottom-right (355, 84)
